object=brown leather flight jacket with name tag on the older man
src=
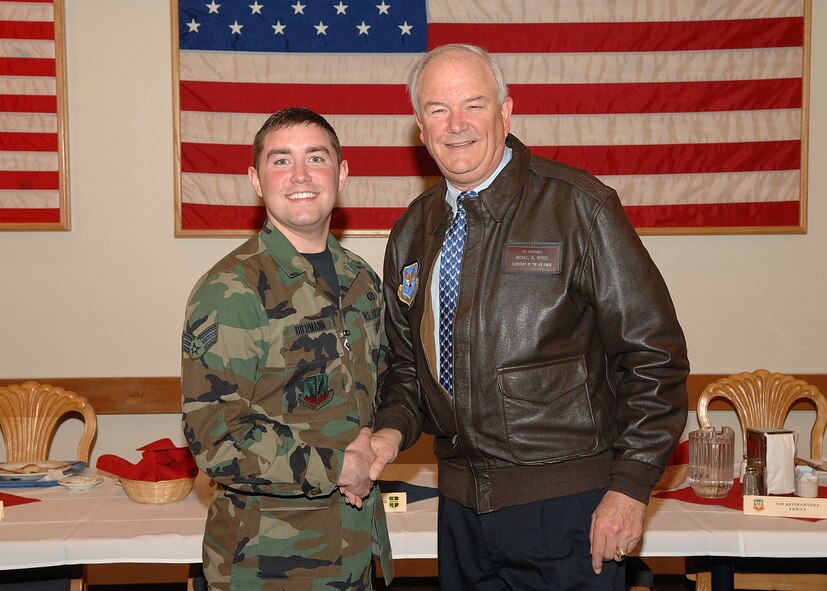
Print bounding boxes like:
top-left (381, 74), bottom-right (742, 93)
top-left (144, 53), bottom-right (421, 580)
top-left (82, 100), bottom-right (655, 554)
top-left (376, 136), bottom-right (689, 513)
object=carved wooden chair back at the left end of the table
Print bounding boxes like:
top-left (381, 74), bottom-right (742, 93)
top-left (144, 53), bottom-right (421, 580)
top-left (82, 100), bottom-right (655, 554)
top-left (0, 381), bottom-right (98, 464)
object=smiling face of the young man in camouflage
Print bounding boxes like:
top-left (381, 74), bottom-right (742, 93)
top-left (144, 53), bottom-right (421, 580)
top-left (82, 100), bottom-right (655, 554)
top-left (247, 124), bottom-right (348, 253)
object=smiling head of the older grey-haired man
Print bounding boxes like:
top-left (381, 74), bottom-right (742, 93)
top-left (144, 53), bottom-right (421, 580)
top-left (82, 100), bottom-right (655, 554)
top-left (416, 51), bottom-right (512, 191)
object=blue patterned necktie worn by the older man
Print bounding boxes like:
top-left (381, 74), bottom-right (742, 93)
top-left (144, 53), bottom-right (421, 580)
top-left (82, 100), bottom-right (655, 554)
top-left (439, 191), bottom-right (477, 396)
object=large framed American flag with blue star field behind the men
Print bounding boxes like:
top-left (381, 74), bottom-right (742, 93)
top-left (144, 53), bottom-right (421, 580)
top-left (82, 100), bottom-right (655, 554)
top-left (173, 0), bottom-right (810, 235)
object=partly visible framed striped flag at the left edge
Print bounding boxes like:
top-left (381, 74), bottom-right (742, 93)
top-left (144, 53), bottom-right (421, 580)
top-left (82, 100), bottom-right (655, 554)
top-left (0, 0), bottom-right (70, 230)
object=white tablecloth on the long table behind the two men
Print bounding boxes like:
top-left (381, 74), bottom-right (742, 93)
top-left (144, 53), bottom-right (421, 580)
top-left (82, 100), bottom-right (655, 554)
top-left (0, 465), bottom-right (827, 570)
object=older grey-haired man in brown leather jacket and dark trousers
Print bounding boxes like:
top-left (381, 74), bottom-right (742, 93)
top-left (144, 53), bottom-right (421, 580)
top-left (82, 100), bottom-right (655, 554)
top-left (371, 45), bottom-right (689, 591)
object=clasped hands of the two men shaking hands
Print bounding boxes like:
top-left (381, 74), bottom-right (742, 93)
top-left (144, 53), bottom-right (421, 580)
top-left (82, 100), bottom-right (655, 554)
top-left (336, 427), bottom-right (402, 508)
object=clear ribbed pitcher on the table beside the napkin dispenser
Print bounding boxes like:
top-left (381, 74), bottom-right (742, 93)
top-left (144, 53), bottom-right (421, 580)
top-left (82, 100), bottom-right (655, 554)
top-left (689, 427), bottom-right (735, 498)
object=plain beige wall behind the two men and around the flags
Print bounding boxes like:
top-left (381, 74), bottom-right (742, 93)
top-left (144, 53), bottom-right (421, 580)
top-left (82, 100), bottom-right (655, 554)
top-left (0, 0), bottom-right (827, 462)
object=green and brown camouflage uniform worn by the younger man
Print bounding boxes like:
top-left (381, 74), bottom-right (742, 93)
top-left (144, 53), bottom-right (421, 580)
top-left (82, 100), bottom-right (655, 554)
top-left (181, 221), bottom-right (393, 591)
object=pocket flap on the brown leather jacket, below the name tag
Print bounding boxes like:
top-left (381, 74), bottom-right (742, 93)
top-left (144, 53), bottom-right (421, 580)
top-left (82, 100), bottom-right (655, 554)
top-left (497, 357), bottom-right (586, 402)
